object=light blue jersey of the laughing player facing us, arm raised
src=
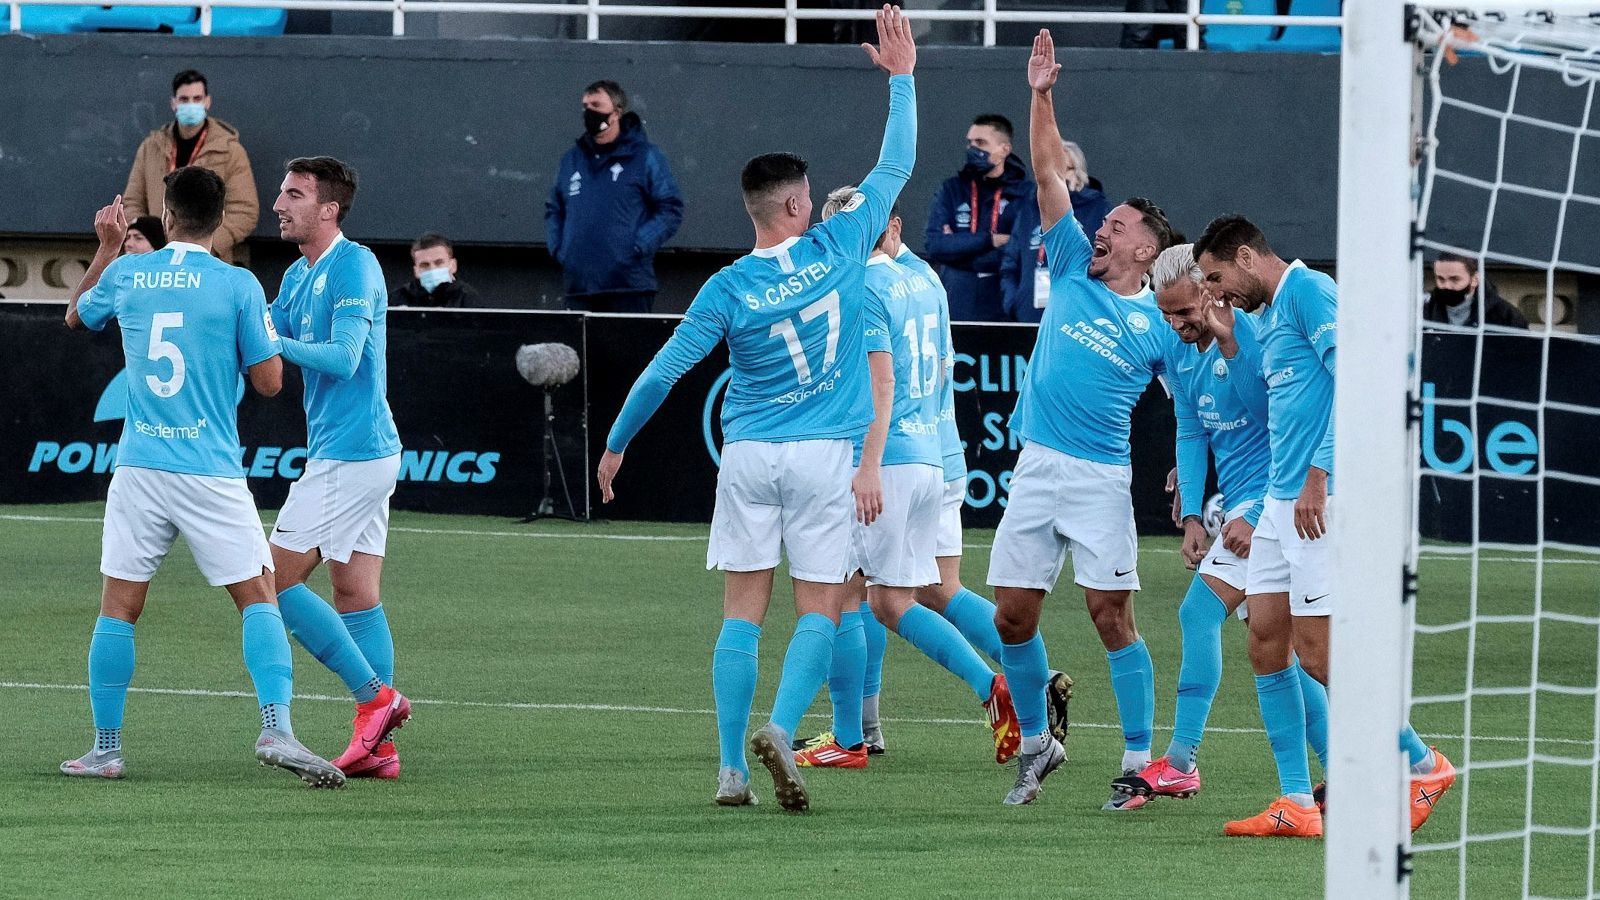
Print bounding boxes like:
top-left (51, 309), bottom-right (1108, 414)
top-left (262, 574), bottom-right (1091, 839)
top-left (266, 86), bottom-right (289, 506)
top-left (1011, 215), bottom-right (1179, 466)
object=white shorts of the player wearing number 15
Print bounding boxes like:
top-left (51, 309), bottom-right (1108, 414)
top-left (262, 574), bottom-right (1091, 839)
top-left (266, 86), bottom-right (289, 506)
top-left (854, 463), bottom-right (944, 588)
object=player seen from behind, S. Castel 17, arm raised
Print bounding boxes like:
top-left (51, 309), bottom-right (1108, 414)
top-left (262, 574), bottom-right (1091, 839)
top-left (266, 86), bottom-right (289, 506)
top-left (597, 6), bottom-right (917, 812)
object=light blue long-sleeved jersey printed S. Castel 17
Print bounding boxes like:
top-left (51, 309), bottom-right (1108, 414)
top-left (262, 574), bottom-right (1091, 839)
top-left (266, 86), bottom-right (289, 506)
top-left (606, 75), bottom-right (917, 453)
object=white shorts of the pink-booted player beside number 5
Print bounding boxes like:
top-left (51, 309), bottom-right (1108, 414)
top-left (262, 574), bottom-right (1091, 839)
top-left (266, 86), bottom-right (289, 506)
top-left (272, 453), bottom-right (400, 562)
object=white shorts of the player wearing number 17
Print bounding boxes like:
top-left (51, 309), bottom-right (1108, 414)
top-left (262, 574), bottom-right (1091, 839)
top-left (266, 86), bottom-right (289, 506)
top-left (706, 439), bottom-right (856, 585)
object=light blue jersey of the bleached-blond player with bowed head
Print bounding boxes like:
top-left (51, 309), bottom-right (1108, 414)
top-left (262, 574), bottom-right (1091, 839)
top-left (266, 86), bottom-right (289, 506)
top-left (1166, 312), bottom-right (1272, 525)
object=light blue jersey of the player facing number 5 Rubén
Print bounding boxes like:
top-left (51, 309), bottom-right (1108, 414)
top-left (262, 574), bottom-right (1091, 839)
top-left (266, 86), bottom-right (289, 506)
top-left (272, 234), bottom-right (400, 461)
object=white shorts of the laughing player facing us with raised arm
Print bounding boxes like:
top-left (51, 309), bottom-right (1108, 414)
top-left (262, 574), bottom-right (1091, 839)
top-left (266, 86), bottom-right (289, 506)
top-left (989, 444), bottom-right (1139, 591)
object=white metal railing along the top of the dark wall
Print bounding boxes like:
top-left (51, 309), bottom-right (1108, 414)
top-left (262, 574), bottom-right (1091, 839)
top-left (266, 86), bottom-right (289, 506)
top-left (8, 0), bottom-right (1344, 50)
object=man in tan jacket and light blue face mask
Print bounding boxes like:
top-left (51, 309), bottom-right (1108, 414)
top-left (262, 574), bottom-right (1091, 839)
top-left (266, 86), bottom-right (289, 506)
top-left (122, 69), bottom-right (261, 263)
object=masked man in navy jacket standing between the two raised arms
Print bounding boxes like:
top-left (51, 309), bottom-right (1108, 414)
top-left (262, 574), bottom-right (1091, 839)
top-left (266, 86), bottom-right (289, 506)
top-left (923, 114), bottom-right (1034, 322)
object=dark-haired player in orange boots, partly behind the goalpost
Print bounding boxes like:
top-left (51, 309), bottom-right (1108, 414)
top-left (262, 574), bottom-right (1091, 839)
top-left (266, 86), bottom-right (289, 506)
top-left (1194, 216), bottom-right (1456, 838)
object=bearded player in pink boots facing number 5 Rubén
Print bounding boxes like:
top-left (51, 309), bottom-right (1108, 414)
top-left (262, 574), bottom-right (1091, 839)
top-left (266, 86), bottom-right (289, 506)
top-left (272, 157), bottom-right (411, 778)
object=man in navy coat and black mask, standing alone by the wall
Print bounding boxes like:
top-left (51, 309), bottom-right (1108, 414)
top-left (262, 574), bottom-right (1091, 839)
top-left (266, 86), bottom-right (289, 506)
top-left (544, 82), bottom-right (683, 312)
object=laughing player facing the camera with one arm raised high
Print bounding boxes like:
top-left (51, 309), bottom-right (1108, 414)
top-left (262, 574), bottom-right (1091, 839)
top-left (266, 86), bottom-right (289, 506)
top-left (989, 30), bottom-right (1174, 809)
